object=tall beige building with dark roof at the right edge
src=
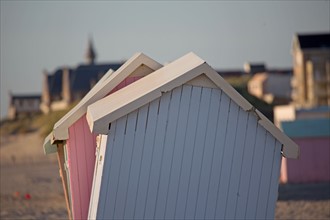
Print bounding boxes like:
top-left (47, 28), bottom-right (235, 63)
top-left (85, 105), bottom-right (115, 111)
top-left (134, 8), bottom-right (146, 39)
top-left (292, 33), bottom-right (330, 107)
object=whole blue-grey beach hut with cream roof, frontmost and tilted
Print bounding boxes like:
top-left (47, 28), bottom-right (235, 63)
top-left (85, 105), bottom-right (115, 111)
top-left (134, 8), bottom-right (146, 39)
top-left (86, 53), bottom-right (299, 219)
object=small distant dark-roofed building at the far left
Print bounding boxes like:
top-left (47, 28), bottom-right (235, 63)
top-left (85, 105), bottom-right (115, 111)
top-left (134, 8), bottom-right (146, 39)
top-left (7, 92), bottom-right (41, 119)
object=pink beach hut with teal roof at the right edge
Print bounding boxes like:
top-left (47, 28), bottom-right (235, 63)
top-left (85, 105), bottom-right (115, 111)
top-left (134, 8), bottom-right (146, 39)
top-left (281, 118), bottom-right (330, 183)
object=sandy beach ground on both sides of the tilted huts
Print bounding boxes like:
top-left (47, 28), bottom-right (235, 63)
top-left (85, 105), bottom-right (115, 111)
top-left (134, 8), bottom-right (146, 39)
top-left (0, 132), bottom-right (330, 219)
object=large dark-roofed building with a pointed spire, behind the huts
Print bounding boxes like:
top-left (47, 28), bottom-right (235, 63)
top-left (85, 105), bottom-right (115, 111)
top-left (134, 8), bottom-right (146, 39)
top-left (40, 39), bottom-right (122, 113)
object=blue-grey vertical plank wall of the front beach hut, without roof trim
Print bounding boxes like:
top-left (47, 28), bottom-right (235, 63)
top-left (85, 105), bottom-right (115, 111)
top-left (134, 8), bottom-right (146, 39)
top-left (94, 85), bottom-right (281, 219)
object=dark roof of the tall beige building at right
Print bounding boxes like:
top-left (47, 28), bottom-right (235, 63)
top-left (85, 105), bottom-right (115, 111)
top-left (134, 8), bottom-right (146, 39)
top-left (297, 33), bottom-right (330, 49)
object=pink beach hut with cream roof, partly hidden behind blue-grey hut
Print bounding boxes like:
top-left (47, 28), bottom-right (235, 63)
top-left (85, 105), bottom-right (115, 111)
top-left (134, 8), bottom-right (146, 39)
top-left (44, 53), bottom-right (161, 219)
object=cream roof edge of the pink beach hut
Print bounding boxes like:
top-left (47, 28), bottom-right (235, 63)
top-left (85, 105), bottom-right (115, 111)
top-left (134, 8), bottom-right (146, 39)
top-left (53, 53), bottom-right (162, 140)
